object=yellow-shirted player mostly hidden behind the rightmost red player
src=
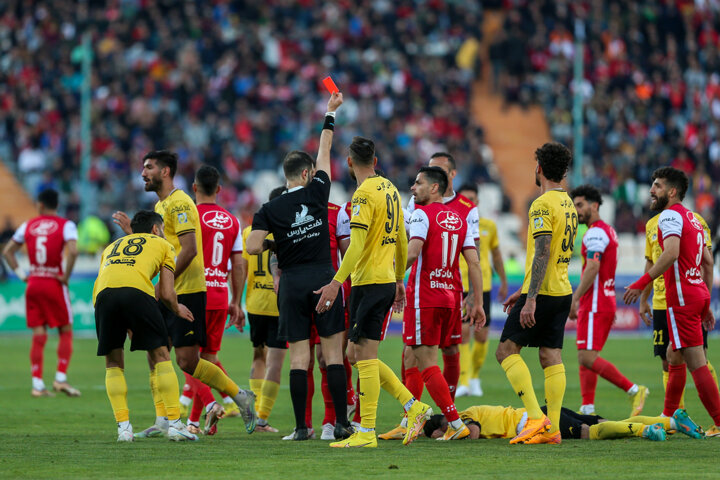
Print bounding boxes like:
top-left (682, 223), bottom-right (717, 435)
top-left (640, 212), bottom-right (718, 402)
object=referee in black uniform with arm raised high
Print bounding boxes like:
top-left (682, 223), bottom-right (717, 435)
top-left (247, 93), bottom-right (352, 440)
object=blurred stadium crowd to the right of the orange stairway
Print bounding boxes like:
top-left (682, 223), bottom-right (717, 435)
top-left (490, 0), bottom-right (720, 233)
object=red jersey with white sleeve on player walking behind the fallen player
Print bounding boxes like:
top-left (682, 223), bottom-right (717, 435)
top-left (579, 220), bottom-right (618, 313)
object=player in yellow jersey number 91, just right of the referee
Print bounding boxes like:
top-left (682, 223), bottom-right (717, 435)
top-left (317, 137), bottom-right (430, 447)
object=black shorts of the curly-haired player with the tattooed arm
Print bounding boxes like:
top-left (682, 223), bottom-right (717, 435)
top-left (500, 294), bottom-right (572, 348)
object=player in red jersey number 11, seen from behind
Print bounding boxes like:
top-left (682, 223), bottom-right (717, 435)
top-left (403, 167), bottom-right (485, 440)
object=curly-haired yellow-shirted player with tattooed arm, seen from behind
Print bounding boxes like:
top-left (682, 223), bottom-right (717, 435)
top-left (495, 142), bottom-right (578, 444)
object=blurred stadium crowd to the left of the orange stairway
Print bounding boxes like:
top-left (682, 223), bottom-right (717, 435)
top-left (0, 0), bottom-right (497, 238)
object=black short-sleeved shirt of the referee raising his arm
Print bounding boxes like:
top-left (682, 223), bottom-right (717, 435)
top-left (252, 170), bottom-right (332, 270)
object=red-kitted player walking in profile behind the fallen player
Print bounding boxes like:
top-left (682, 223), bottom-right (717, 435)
top-left (570, 185), bottom-right (648, 417)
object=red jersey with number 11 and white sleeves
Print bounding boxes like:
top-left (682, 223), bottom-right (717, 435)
top-left (407, 202), bottom-right (475, 309)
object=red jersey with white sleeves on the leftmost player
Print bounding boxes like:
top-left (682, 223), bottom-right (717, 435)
top-left (13, 215), bottom-right (77, 277)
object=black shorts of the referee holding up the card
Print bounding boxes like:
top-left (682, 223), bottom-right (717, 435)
top-left (278, 264), bottom-right (345, 342)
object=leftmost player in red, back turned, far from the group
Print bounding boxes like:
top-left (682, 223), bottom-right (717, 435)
top-left (3, 190), bottom-right (80, 397)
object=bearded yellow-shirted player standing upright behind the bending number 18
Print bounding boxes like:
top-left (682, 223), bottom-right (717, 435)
top-left (113, 150), bottom-right (256, 438)
